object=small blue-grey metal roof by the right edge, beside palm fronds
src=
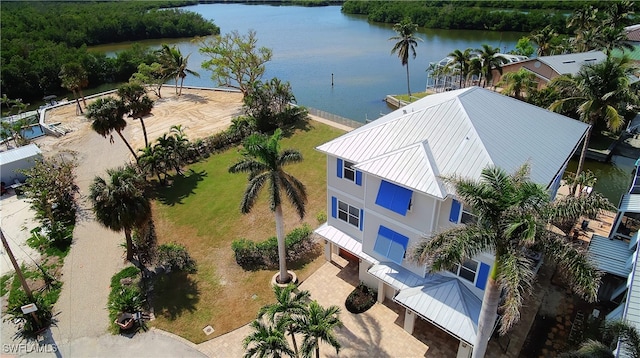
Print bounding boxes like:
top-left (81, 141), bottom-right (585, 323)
top-left (589, 234), bottom-right (633, 277)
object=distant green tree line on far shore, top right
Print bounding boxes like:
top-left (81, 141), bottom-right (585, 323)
top-left (342, 0), bottom-right (637, 33)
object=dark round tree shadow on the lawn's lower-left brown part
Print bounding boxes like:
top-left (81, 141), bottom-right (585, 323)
top-left (152, 271), bottom-right (200, 320)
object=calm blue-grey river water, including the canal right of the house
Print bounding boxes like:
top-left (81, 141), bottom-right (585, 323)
top-left (86, 4), bottom-right (635, 205)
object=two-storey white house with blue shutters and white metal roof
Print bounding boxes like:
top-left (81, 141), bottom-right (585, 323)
top-left (316, 87), bottom-right (588, 357)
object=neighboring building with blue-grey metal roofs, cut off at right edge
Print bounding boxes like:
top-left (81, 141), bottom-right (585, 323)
top-left (589, 159), bottom-right (640, 357)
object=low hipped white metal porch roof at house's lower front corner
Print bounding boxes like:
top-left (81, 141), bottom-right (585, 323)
top-left (394, 275), bottom-right (482, 345)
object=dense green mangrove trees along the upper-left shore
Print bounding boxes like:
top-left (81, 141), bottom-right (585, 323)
top-left (0, 1), bottom-right (220, 100)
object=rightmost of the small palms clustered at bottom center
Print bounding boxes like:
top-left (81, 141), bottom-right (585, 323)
top-left (298, 301), bottom-right (342, 358)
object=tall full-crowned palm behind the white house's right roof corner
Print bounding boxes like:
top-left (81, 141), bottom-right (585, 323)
top-left (549, 56), bottom-right (638, 194)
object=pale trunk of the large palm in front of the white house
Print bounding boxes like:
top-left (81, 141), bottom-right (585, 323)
top-left (471, 276), bottom-right (500, 358)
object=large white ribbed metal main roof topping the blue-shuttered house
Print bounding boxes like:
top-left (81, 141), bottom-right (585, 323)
top-left (317, 87), bottom-right (588, 199)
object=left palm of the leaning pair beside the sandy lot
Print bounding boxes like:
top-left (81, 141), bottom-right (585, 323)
top-left (86, 97), bottom-right (138, 161)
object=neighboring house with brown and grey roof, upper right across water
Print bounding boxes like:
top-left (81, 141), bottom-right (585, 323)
top-left (493, 51), bottom-right (607, 88)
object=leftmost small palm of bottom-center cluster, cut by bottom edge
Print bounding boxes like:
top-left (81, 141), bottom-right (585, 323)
top-left (242, 320), bottom-right (295, 358)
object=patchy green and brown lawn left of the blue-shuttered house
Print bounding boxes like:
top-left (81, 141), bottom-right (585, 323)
top-left (152, 121), bottom-right (344, 343)
